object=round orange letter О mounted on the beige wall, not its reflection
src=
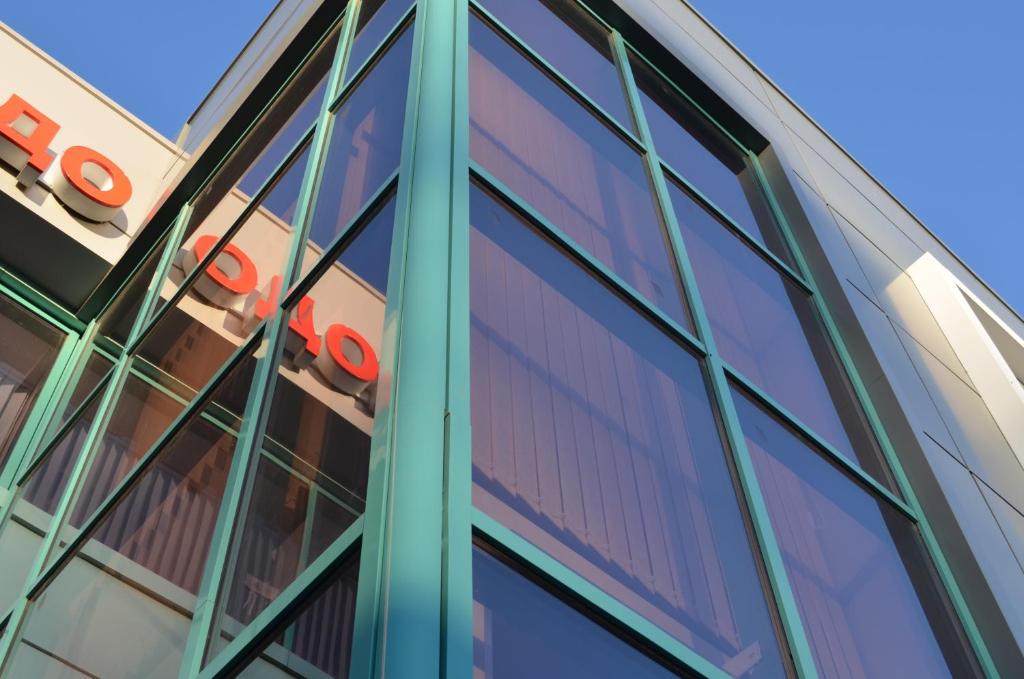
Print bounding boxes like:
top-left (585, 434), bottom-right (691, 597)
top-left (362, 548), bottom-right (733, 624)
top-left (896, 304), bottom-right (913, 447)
top-left (53, 146), bottom-right (131, 221)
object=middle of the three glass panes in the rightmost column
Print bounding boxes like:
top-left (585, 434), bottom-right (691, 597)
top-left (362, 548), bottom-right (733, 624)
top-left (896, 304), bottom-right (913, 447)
top-left (669, 182), bottom-right (892, 485)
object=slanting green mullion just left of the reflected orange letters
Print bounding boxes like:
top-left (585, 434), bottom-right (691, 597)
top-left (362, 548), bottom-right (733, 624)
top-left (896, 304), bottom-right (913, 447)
top-left (0, 206), bottom-right (189, 677)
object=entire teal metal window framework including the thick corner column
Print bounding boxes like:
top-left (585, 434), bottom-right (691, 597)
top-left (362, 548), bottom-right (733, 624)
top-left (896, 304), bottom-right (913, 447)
top-left (0, 0), bottom-right (998, 679)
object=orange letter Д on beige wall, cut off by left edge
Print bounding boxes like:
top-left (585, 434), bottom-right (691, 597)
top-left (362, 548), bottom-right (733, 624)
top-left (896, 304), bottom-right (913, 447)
top-left (0, 94), bottom-right (60, 184)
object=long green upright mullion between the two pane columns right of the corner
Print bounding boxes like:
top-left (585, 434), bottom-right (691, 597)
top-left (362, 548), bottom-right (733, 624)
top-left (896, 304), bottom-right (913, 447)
top-left (612, 31), bottom-right (818, 679)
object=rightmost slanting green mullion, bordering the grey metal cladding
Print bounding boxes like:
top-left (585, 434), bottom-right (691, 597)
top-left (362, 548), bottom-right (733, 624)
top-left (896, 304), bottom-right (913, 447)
top-left (749, 152), bottom-right (999, 677)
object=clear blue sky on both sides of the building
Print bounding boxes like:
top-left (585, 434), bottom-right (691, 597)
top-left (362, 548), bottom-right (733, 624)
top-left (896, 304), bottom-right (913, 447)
top-left (0, 0), bottom-right (1024, 313)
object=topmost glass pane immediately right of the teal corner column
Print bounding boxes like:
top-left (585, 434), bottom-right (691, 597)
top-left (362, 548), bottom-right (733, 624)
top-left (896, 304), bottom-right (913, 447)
top-left (481, 0), bottom-right (635, 130)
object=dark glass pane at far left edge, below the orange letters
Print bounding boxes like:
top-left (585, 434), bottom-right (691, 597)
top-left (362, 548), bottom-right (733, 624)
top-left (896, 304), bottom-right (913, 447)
top-left (0, 295), bottom-right (66, 469)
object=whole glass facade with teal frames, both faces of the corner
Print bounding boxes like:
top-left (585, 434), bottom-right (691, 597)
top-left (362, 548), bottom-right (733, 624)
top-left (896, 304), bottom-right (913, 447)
top-left (0, 0), bottom-right (1011, 679)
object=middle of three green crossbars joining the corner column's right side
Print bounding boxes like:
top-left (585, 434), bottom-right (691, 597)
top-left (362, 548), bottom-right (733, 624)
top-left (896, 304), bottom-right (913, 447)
top-left (469, 159), bottom-right (707, 356)
